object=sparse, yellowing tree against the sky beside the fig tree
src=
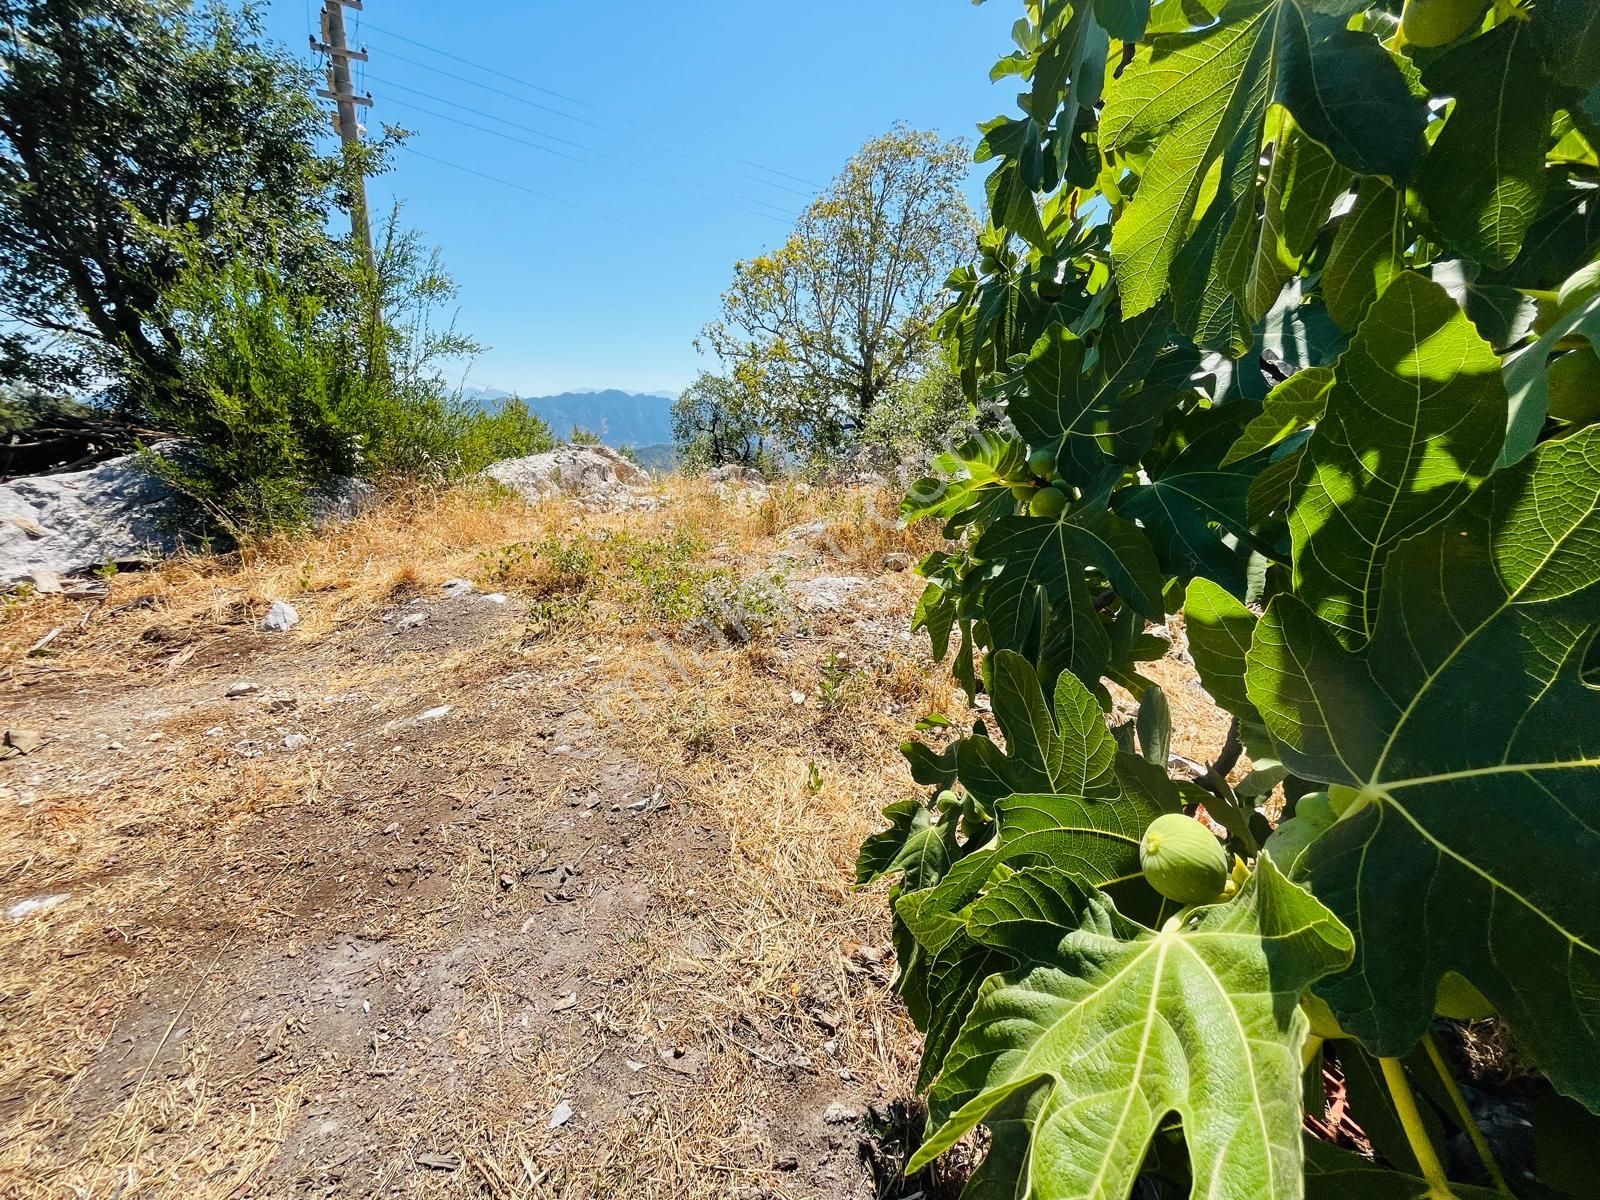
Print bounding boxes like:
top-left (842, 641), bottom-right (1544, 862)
top-left (702, 126), bottom-right (976, 453)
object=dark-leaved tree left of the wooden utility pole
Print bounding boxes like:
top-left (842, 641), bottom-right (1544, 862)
top-left (0, 0), bottom-right (341, 404)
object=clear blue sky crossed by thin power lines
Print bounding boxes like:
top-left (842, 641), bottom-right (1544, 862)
top-left (260, 0), bottom-right (1021, 395)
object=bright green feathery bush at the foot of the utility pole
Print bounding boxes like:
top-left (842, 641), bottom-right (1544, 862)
top-left (150, 219), bottom-right (554, 534)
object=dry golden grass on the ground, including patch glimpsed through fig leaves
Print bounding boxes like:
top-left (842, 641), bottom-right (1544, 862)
top-left (0, 482), bottom-right (1222, 1200)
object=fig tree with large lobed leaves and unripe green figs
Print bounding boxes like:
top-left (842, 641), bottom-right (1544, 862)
top-left (858, 0), bottom-right (1600, 1200)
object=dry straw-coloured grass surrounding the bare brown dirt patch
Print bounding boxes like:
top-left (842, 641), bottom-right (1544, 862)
top-left (0, 483), bottom-right (949, 1197)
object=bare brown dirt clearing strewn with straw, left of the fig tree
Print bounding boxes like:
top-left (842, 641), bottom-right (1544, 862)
top-left (0, 486), bottom-right (960, 1197)
